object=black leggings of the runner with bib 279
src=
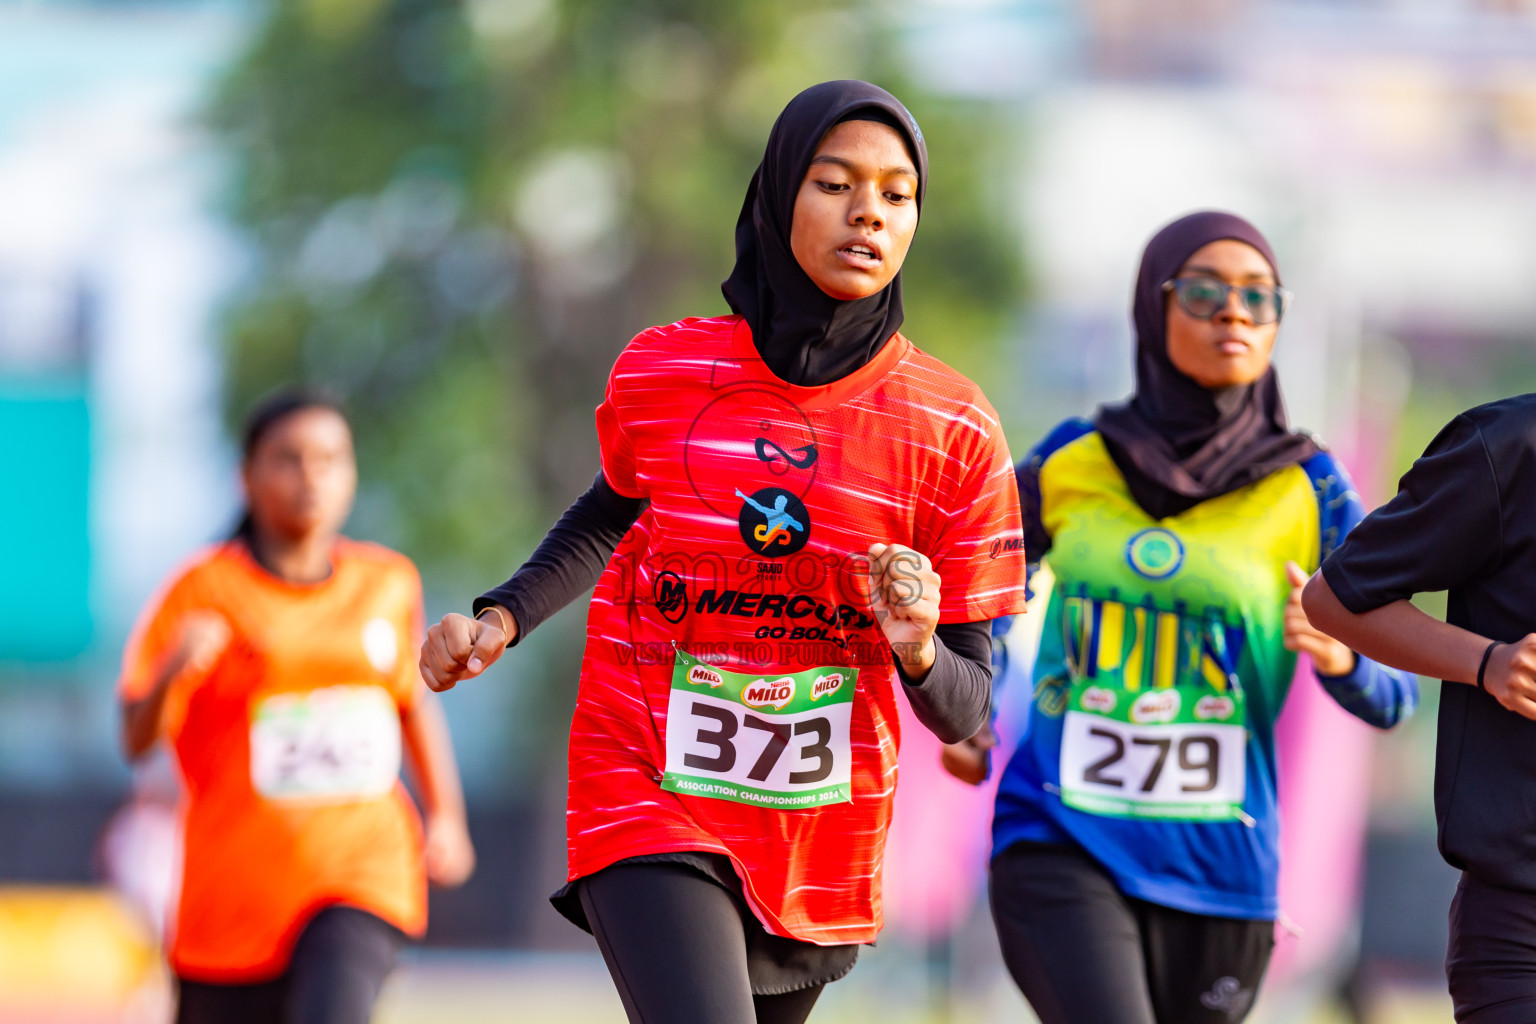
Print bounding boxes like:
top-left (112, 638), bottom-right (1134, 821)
top-left (991, 843), bottom-right (1275, 1024)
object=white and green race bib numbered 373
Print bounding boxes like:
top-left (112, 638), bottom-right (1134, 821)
top-left (662, 649), bottom-right (859, 811)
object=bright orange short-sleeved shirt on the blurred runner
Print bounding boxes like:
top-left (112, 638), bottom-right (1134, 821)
top-left (120, 539), bottom-right (427, 984)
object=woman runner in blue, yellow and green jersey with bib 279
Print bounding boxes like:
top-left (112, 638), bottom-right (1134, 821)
top-left (946, 213), bottom-right (1418, 1024)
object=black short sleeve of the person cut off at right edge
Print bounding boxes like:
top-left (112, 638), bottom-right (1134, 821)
top-left (1322, 415), bottom-right (1504, 614)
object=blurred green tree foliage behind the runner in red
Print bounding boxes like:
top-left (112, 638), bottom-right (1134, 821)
top-left (209, 0), bottom-right (1018, 773)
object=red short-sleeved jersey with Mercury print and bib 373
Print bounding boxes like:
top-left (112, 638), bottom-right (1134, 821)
top-left (567, 316), bottom-right (1025, 944)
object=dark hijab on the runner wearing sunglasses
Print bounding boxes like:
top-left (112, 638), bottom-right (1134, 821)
top-left (1094, 212), bottom-right (1318, 519)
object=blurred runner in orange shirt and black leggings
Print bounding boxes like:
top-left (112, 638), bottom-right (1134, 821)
top-left (120, 393), bottom-right (475, 1024)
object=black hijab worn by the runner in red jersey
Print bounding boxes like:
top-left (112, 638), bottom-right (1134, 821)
top-left (720, 81), bottom-right (928, 387)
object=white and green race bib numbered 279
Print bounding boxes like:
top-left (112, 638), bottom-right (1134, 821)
top-left (1061, 682), bottom-right (1247, 821)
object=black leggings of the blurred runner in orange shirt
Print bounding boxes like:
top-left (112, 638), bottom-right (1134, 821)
top-left (177, 907), bottom-right (406, 1024)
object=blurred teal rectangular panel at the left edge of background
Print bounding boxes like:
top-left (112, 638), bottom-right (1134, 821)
top-left (0, 384), bottom-right (92, 662)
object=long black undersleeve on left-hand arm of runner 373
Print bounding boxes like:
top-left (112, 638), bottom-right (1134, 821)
top-left (475, 473), bottom-right (645, 646)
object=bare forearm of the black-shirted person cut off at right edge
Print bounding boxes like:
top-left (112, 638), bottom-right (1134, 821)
top-left (1301, 574), bottom-right (1488, 683)
